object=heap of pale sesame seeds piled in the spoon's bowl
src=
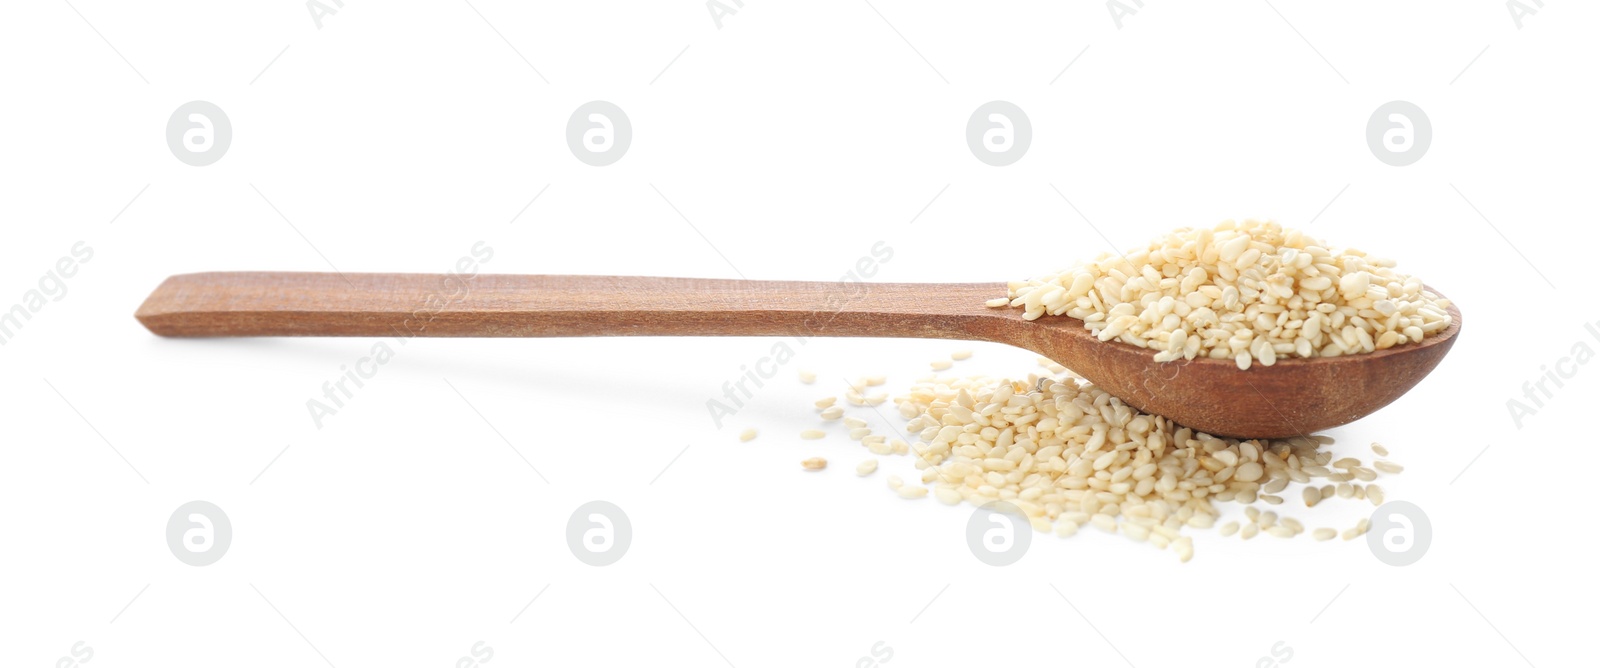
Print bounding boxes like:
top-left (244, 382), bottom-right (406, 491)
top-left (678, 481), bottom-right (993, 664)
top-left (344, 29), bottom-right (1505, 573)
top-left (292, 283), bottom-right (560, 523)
top-left (987, 221), bottom-right (1451, 369)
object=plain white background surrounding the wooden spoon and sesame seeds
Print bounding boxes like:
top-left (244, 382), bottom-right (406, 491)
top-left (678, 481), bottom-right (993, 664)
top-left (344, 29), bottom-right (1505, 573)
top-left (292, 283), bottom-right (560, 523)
top-left (0, 0), bottom-right (1600, 668)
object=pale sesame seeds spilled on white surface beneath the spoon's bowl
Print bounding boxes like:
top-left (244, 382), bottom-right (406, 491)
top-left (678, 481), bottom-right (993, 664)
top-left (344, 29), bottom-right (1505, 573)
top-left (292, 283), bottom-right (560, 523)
top-left (870, 376), bottom-right (1400, 561)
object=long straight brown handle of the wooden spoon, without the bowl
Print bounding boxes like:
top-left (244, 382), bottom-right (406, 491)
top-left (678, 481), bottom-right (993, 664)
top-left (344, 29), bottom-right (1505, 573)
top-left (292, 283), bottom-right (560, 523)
top-left (136, 272), bottom-right (1006, 340)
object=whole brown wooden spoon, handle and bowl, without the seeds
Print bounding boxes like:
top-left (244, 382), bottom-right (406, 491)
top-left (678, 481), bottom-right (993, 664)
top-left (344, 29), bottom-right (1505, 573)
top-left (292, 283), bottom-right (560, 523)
top-left (136, 272), bottom-right (1461, 438)
